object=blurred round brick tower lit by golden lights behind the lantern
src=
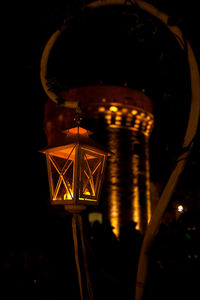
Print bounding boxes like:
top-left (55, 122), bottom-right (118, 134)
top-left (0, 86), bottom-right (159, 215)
top-left (44, 85), bottom-right (154, 235)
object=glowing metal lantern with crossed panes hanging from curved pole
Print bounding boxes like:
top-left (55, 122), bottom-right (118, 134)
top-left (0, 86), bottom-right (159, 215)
top-left (41, 126), bottom-right (108, 211)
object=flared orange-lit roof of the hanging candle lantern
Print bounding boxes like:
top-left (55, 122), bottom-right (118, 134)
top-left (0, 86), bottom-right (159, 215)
top-left (40, 126), bottom-right (109, 155)
